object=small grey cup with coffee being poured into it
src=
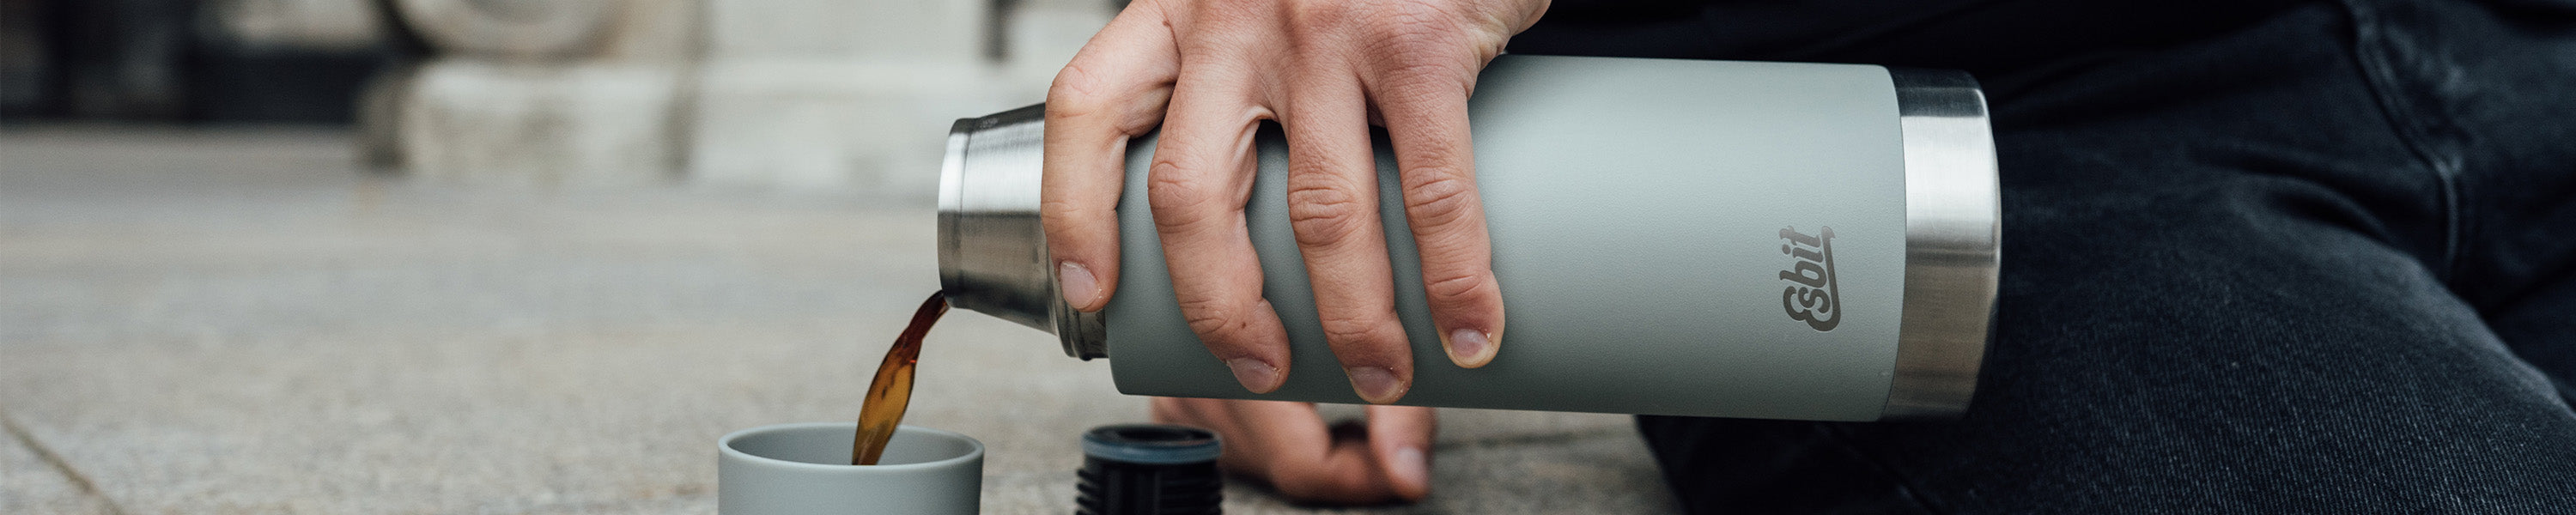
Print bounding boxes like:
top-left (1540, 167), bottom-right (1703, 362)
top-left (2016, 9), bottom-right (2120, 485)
top-left (716, 422), bottom-right (984, 515)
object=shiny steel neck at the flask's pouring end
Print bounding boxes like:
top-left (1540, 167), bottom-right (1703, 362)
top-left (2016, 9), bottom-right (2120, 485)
top-left (940, 103), bottom-right (1108, 360)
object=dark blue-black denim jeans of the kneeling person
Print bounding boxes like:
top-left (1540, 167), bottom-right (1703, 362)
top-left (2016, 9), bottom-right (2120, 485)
top-left (1515, 0), bottom-right (2576, 512)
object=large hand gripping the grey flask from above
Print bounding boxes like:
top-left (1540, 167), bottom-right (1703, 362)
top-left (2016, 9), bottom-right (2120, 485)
top-left (1041, 0), bottom-right (1548, 404)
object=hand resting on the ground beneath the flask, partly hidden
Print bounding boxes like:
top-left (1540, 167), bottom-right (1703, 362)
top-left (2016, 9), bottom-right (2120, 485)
top-left (1154, 397), bottom-right (1437, 505)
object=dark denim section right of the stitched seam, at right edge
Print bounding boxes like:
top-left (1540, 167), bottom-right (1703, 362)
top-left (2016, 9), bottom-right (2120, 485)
top-left (2349, 0), bottom-right (2576, 399)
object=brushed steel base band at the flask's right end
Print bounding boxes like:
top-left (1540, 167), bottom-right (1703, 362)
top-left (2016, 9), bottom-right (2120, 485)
top-left (1880, 67), bottom-right (2004, 420)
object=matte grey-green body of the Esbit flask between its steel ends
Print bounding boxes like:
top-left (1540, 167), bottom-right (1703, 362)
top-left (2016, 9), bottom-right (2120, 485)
top-left (1105, 57), bottom-right (1906, 420)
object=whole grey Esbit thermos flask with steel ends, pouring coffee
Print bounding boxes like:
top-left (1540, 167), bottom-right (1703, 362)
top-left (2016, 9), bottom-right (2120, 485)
top-left (938, 57), bottom-right (2002, 420)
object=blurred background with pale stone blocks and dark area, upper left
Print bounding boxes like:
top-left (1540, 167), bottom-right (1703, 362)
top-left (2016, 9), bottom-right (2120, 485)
top-left (0, 0), bottom-right (1123, 198)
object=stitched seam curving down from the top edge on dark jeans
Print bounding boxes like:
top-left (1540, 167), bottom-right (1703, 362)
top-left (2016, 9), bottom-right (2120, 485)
top-left (2342, 0), bottom-right (2468, 286)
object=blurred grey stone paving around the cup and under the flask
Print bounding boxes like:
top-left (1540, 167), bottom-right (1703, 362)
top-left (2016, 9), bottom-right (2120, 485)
top-left (0, 129), bottom-right (1672, 512)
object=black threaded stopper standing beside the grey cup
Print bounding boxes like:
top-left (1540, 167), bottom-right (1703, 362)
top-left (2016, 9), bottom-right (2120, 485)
top-left (1077, 425), bottom-right (1226, 515)
